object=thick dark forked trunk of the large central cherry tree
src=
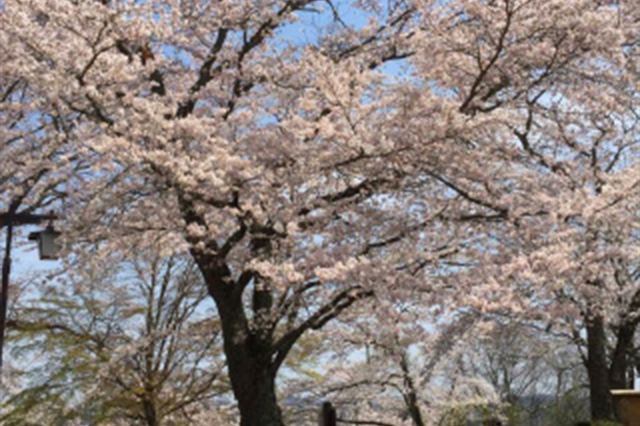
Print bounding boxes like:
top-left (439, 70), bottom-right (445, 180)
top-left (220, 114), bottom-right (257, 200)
top-left (178, 205), bottom-right (373, 426)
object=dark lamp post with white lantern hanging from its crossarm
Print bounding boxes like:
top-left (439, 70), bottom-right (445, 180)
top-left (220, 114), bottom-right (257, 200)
top-left (0, 209), bottom-right (58, 375)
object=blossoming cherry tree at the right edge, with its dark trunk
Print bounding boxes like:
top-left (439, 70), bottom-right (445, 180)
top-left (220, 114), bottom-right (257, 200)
top-left (400, 1), bottom-right (640, 419)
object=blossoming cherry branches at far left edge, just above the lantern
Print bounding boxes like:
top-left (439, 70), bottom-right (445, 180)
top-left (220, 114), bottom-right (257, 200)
top-left (0, 5), bottom-right (85, 233)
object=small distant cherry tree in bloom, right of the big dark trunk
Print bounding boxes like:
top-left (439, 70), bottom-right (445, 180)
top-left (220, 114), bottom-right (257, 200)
top-left (317, 308), bottom-right (480, 426)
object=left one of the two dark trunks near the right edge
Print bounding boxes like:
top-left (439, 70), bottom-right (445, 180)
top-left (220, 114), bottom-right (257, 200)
top-left (586, 315), bottom-right (615, 421)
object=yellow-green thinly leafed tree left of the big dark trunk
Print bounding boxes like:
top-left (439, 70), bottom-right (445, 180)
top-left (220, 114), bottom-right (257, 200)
top-left (3, 257), bottom-right (229, 426)
